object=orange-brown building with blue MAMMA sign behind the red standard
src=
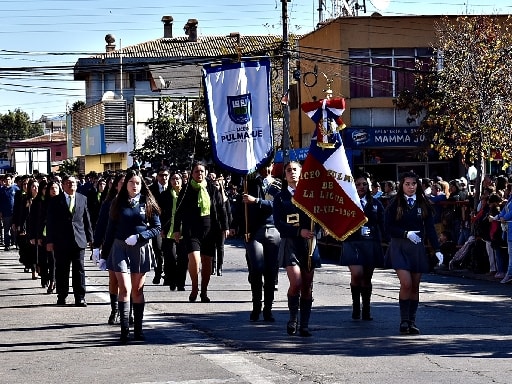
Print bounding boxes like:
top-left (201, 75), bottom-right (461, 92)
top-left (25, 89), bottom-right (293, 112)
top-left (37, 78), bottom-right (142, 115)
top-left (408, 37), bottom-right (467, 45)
top-left (290, 15), bottom-right (465, 180)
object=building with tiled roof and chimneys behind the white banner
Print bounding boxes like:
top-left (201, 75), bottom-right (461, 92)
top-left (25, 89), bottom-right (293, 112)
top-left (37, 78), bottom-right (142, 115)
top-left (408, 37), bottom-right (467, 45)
top-left (68, 16), bottom-right (282, 173)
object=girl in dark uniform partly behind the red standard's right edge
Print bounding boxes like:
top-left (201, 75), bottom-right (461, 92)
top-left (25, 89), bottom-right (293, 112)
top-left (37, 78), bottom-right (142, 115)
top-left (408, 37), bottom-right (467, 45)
top-left (341, 174), bottom-right (384, 320)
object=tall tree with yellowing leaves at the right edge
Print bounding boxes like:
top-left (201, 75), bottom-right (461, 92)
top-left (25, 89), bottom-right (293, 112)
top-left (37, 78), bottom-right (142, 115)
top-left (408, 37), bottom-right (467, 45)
top-left (396, 16), bottom-right (512, 201)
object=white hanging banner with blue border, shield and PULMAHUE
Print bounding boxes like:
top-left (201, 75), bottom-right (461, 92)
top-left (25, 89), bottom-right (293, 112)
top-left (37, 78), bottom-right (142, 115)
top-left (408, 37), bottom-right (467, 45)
top-left (203, 59), bottom-right (274, 174)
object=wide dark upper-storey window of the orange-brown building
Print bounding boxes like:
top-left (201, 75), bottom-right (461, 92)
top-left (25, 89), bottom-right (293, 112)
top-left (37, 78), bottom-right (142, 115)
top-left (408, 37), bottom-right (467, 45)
top-left (349, 48), bottom-right (433, 98)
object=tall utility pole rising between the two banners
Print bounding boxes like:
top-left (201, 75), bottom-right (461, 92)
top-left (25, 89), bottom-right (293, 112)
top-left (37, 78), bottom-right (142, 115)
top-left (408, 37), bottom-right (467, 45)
top-left (281, 0), bottom-right (291, 165)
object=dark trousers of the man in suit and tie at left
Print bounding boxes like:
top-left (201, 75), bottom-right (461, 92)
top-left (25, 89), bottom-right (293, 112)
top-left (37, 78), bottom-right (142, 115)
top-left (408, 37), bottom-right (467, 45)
top-left (54, 247), bottom-right (85, 301)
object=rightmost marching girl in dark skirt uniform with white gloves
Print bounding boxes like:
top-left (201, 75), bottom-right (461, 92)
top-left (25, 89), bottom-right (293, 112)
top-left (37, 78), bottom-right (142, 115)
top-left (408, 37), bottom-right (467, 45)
top-left (384, 172), bottom-right (443, 335)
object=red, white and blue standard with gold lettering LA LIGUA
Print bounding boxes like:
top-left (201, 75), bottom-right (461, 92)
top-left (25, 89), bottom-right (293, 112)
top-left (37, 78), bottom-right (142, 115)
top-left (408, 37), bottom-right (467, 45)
top-left (292, 98), bottom-right (368, 241)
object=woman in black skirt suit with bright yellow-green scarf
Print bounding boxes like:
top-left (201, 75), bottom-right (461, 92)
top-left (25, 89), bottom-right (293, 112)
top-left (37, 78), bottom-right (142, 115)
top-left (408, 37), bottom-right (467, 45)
top-left (174, 162), bottom-right (229, 303)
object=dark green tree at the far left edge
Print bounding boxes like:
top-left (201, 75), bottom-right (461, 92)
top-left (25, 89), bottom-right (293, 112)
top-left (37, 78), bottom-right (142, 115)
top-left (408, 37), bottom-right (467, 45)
top-left (0, 109), bottom-right (43, 148)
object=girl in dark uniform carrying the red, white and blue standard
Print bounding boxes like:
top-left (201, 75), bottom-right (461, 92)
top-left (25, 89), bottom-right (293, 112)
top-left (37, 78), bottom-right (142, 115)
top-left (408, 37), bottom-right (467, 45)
top-left (273, 161), bottom-right (316, 337)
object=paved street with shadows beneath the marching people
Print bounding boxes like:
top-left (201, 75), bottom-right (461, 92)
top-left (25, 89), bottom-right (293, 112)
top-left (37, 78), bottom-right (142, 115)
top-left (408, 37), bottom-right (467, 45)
top-left (0, 242), bottom-right (512, 384)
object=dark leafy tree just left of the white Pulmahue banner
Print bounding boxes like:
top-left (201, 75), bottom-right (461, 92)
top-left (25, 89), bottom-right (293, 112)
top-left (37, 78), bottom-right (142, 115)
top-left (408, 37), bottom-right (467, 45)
top-left (130, 97), bottom-right (211, 169)
